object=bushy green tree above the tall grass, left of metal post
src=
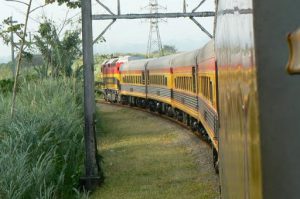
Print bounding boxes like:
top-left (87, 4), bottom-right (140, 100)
top-left (34, 20), bottom-right (81, 77)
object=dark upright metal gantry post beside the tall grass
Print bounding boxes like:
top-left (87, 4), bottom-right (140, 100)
top-left (81, 0), bottom-right (101, 190)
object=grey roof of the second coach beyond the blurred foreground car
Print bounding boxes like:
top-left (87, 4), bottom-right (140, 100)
top-left (172, 49), bottom-right (200, 67)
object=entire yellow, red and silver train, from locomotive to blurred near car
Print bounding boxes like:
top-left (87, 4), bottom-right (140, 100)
top-left (103, 0), bottom-right (300, 199)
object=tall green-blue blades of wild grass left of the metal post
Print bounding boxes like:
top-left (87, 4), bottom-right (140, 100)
top-left (0, 80), bottom-right (84, 199)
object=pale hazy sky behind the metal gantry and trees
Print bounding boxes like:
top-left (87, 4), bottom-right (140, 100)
top-left (0, 0), bottom-right (215, 62)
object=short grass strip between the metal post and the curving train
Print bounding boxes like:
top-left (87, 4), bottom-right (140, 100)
top-left (92, 105), bottom-right (219, 199)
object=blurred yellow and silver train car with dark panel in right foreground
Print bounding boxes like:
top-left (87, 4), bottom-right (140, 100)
top-left (215, 0), bottom-right (300, 199)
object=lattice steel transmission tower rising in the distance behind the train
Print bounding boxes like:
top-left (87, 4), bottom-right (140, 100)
top-left (147, 0), bottom-right (164, 57)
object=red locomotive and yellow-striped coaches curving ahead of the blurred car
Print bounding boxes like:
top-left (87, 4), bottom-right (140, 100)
top-left (102, 41), bottom-right (218, 159)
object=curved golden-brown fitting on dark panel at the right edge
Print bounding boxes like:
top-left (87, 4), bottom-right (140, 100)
top-left (287, 28), bottom-right (300, 74)
